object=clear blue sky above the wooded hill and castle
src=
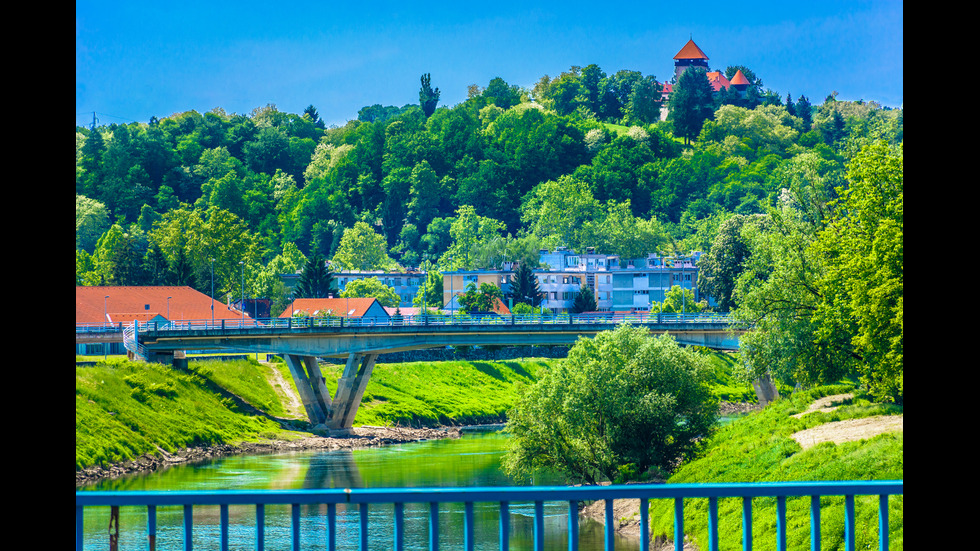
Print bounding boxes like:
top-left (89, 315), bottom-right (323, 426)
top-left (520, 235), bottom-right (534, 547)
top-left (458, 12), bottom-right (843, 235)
top-left (75, 0), bottom-right (904, 125)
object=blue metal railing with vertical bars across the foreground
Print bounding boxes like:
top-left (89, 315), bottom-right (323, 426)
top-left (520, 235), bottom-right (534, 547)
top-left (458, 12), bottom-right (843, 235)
top-left (75, 480), bottom-right (904, 551)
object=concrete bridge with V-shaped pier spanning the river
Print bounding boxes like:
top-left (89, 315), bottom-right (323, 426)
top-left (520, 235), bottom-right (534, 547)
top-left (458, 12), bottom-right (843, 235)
top-left (111, 314), bottom-right (742, 433)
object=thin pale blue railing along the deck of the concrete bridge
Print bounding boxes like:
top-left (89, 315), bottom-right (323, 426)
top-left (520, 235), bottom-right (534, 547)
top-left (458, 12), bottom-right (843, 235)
top-left (82, 312), bottom-right (733, 332)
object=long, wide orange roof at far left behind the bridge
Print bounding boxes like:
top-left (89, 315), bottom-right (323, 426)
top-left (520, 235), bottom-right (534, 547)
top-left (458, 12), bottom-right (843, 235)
top-left (75, 286), bottom-right (250, 323)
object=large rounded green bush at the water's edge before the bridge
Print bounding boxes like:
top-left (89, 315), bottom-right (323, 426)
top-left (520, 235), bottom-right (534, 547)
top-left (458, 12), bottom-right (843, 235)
top-left (504, 325), bottom-right (718, 484)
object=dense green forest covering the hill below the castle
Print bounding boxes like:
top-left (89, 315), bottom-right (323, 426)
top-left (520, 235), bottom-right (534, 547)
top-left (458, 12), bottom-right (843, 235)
top-left (75, 65), bottom-right (903, 402)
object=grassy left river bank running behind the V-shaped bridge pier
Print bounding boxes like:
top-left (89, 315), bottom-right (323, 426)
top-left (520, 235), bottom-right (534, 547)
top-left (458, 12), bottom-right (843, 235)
top-left (75, 359), bottom-right (553, 469)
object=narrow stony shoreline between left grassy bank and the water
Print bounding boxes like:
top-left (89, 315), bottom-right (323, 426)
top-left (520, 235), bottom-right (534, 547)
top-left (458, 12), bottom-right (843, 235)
top-left (75, 426), bottom-right (462, 488)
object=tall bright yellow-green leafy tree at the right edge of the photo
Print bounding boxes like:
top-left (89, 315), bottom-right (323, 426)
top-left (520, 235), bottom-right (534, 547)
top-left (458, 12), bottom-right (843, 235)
top-left (814, 141), bottom-right (905, 402)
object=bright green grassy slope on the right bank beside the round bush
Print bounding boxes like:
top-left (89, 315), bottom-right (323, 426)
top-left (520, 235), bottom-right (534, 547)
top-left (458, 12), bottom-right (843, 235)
top-left (650, 386), bottom-right (904, 549)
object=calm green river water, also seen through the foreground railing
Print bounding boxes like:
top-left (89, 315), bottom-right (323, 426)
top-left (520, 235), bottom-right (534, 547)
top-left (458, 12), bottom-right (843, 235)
top-left (78, 431), bottom-right (639, 551)
